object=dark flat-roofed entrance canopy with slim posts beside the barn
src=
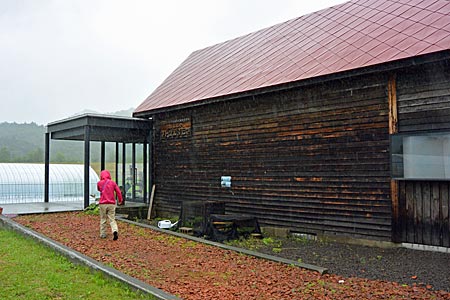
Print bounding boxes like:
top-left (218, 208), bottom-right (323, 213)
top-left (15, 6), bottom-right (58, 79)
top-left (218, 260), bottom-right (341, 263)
top-left (44, 114), bottom-right (153, 207)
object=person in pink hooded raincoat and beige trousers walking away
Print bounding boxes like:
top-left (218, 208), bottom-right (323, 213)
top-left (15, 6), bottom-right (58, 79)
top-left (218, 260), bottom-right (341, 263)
top-left (97, 170), bottom-right (123, 241)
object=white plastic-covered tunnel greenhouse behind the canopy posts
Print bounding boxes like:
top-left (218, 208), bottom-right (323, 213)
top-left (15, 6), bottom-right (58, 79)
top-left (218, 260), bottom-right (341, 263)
top-left (0, 163), bottom-right (99, 204)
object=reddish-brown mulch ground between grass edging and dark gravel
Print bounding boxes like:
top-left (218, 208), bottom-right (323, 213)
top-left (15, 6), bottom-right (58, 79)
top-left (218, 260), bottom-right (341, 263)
top-left (14, 212), bottom-right (450, 299)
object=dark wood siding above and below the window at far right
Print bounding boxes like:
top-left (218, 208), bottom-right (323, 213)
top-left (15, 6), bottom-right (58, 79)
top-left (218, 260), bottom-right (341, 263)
top-left (397, 61), bottom-right (450, 247)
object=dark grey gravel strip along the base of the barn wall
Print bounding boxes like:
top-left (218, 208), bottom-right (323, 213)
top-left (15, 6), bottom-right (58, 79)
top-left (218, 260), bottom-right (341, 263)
top-left (251, 239), bottom-right (450, 291)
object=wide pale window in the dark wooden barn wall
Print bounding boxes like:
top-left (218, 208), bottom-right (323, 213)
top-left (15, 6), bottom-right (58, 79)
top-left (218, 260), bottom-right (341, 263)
top-left (391, 132), bottom-right (450, 180)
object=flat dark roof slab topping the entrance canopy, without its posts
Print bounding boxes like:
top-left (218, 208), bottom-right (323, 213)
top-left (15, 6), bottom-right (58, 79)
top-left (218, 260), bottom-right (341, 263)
top-left (47, 114), bottom-right (152, 143)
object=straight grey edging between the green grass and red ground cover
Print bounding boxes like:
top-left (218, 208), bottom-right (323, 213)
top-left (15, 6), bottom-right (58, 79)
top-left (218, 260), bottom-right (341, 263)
top-left (0, 215), bottom-right (181, 300)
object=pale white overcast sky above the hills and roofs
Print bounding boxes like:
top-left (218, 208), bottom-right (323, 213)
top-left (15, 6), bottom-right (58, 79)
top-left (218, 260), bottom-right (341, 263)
top-left (0, 0), bottom-right (345, 125)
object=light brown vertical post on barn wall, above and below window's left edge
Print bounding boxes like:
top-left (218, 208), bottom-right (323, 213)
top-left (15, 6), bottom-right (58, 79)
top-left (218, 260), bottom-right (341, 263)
top-left (388, 74), bottom-right (401, 243)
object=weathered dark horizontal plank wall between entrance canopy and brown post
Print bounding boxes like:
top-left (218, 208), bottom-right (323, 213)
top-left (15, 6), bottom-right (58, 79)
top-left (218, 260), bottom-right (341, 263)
top-left (154, 75), bottom-right (391, 240)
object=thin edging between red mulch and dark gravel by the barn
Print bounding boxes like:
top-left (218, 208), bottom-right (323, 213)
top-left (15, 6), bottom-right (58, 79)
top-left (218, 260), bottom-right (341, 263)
top-left (117, 218), bottom-right (328, 275)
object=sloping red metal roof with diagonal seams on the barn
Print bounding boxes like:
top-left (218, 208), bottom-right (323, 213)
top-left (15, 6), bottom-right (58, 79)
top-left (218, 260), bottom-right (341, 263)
top-left (135, 0), bottom-right (450, 113)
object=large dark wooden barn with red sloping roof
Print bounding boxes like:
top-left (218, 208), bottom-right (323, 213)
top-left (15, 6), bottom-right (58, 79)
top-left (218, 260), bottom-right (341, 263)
top-left (133, 0), bottom-right (450, 247)
